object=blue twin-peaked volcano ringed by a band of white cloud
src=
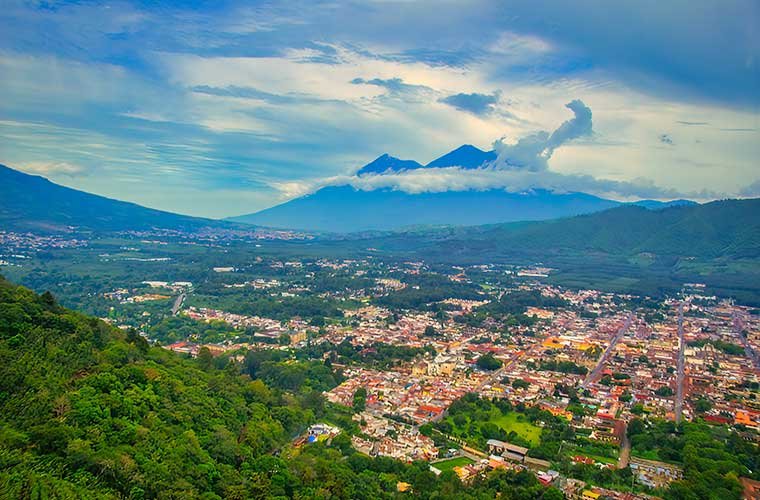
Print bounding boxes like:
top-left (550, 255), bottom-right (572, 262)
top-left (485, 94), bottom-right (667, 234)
top-left (227, 144), bottom-right (693, 233)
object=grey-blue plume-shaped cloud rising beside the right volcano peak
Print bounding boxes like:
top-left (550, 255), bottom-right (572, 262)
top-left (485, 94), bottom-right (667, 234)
top-left (493, 99), bottom-right (593, 172)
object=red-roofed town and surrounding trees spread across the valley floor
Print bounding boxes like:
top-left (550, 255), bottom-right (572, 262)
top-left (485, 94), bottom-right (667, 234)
top-left (0, 216), bottom-right (760, 499)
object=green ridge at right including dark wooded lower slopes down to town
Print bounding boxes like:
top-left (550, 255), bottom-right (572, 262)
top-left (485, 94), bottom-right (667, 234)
top-left (354, 199), bottom-right (760, 306)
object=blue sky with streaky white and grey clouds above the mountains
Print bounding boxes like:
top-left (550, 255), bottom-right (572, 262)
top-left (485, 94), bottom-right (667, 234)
top-left (0, 0), bottom-right (760, 217)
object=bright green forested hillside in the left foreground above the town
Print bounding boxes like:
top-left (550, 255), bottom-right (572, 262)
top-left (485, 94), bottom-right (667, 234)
top-left (0, 278), bottom-right (561, 499)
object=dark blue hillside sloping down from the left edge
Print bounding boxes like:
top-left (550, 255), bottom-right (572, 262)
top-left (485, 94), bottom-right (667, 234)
top-left (0, 165), bottom-right (230, 232)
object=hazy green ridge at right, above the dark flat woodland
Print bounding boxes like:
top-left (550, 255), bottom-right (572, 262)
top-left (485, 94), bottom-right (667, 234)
top-left (418, 199), bottom-right (760, 258)
